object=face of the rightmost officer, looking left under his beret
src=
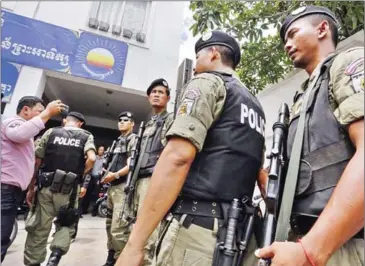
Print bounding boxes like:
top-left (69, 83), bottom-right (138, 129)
top-left (285, 17), bottom-right (321, 68)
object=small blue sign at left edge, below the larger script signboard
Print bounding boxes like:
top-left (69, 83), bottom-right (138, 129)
top-left (1, 60), bottom-right (21, 103)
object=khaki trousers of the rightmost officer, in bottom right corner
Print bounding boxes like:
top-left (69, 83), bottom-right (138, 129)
top-left (290, 235), bottom-right (364, 266)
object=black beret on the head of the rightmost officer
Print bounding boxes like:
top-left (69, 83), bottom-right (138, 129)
top-left (280, 6), bottom-right (337, 42)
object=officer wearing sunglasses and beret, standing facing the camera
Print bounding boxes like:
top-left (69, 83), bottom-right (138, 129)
top-left (101, 112), bottom-right (136, 266)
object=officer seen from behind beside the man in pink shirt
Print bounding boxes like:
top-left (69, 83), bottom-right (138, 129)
top-left (24, 112), bottom-right (95, 266)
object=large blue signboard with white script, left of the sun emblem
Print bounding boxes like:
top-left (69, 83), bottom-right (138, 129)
top-left (1, 10), bottom-right (78, 72)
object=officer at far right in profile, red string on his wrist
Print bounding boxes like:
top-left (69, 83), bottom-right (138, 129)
top-left (258, 6), bottom-right (364, 266)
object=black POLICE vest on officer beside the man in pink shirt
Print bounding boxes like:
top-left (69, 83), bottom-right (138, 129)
top-left (43, 127), bottom-right (90, 176)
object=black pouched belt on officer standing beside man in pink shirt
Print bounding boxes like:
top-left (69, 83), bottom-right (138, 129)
top-left (38, 169), bottom-right (80, 194)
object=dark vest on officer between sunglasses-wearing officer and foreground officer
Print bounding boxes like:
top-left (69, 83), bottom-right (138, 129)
top-left (139, 113), bottom-right (171, 177)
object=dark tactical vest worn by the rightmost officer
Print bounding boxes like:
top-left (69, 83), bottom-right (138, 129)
top-left (287, 58), bottom-right (355, 217)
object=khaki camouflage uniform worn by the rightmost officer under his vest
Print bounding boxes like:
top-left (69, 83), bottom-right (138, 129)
top-left (291, 47), bottom-right (364, 266)
